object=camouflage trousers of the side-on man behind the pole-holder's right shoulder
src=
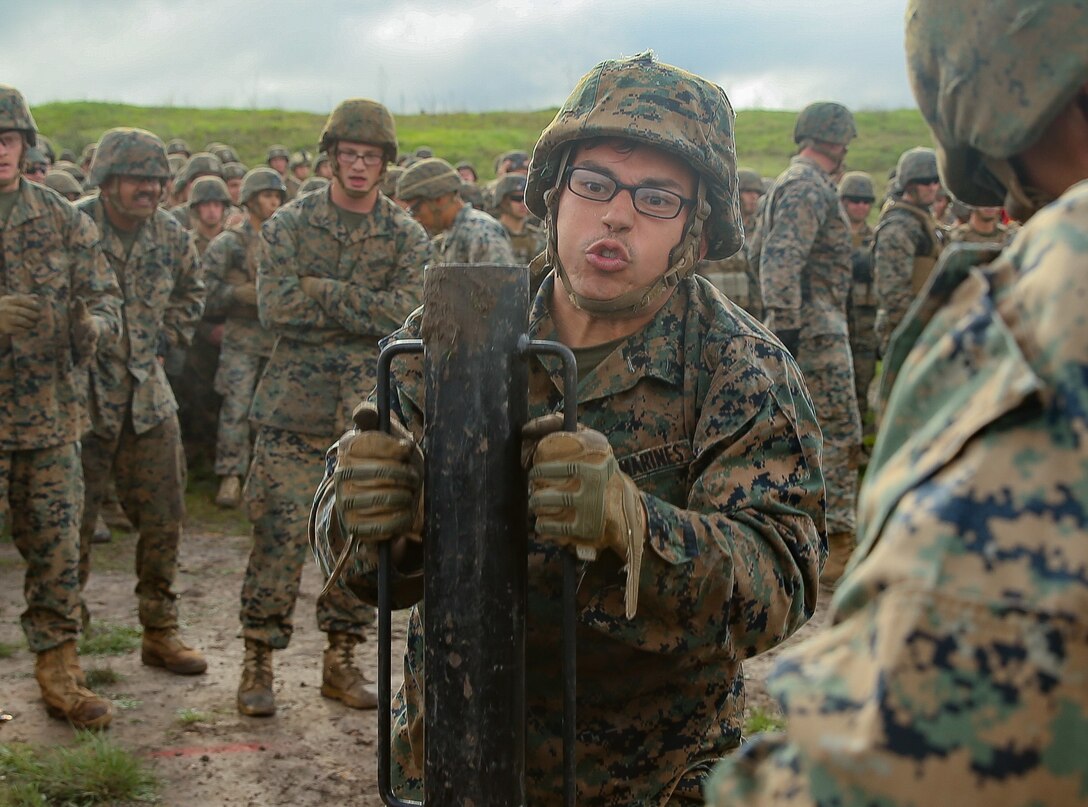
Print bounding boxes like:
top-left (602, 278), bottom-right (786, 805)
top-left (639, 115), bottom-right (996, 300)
top-left (795, 336), bottom-right (862, 535)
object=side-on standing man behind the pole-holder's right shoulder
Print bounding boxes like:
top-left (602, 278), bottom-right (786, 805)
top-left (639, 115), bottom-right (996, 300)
top-left (753, 101), bottom-right (862, 584)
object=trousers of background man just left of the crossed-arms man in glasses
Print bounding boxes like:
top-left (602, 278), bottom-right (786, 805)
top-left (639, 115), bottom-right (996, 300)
top-left (215, 345), bottom-right (268, 476)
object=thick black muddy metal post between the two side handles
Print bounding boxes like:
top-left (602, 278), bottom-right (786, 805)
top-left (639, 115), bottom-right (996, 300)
top-left (421, 264), bottom-right (529, 807)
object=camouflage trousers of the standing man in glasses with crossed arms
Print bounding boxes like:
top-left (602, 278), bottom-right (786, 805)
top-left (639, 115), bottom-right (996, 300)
top-left (240, 426), bottom-right (374, 649)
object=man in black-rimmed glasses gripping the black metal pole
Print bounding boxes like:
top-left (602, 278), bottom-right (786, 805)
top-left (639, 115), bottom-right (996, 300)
top-left (312, 53), bottom-right (826, 806)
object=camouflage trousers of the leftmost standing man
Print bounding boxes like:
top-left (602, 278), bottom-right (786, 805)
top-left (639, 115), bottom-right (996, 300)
top-left (0, 443), bottom-right (83, 654)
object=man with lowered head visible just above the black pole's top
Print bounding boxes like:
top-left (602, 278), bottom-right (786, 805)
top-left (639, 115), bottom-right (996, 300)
top-left (397, 157), bottom-right (517, 265)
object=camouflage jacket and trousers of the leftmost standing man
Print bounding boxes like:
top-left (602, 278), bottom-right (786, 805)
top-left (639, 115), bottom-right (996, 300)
top-left (0, 179), bottom-right (121, 654)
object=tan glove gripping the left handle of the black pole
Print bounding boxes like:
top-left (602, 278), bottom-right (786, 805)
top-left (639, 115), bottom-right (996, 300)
top-left (333, 404), bottom-right (423, 544)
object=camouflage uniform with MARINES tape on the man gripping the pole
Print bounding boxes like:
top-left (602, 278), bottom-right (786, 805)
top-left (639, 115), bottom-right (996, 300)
top-left (314, 275), bottom-right (827, 805)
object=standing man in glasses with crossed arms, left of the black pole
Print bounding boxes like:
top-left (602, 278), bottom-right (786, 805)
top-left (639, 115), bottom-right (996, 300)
top-left (237, 98), bottom-right (431, 715)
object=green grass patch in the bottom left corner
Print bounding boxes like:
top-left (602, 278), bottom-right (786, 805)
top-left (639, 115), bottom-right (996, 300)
top-left (0, 731), bottom-right (159, 807)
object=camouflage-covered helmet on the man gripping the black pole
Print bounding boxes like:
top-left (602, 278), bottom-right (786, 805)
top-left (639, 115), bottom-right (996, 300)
top-left (526, 51), bottom-right (744, 262)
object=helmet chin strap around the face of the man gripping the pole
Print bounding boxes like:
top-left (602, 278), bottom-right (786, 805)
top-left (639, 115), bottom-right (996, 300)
top-left (544, 148), bottom-right (710, 320)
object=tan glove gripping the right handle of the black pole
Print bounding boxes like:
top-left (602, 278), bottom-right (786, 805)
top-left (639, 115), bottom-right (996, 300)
top-left (522, 415), bottom-right (646, 619)
